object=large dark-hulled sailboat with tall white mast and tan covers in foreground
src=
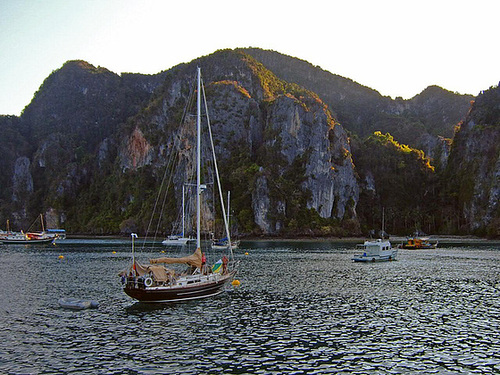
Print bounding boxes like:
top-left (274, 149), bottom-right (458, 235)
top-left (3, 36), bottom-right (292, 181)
top-left (120, 68), bottom-right (237, 302)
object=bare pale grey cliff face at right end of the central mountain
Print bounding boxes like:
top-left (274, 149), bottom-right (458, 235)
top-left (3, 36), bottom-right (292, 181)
top-left (267, 96), bottom-right (359, 232)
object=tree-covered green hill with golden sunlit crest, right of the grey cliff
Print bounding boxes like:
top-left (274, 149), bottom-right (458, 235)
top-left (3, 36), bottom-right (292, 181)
top-left (354, 132), bottom-right (438, 234)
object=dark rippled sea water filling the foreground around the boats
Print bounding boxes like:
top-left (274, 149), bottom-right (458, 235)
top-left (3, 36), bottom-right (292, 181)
top-left (0, 239), bottom-right (500, 374)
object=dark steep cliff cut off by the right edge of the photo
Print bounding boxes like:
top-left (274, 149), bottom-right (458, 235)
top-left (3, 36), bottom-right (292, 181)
top-left (448, 86), bottom-right (500, 236)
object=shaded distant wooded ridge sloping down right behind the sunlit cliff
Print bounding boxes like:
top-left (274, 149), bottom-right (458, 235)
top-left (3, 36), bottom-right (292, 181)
top-left (244, 48), bottom-right (473, 163)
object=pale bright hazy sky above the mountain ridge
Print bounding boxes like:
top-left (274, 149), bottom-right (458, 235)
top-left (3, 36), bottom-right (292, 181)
top-left (0, 0), bottom-right (500, 115)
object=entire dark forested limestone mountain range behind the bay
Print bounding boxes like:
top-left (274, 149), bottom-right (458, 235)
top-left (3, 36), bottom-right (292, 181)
top-left (0, 48), bottom-right (500, 236)
